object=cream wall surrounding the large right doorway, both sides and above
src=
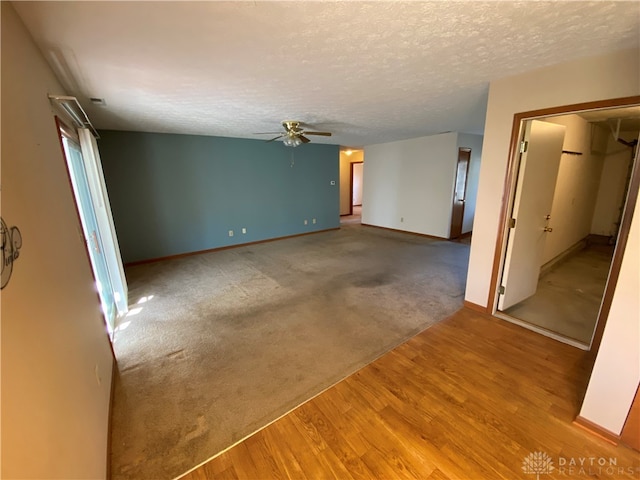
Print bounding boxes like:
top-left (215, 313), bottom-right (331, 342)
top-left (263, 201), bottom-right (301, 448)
top-left (465, 49), bottom-right (640, 432)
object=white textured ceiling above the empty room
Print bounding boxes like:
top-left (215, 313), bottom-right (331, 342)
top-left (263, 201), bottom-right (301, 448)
top-left (14, 1), bottom-right (640, 146)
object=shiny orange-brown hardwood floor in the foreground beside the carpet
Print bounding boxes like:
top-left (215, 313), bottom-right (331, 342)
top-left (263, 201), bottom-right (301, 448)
top-left (182, 309), bottom-right (640, 480)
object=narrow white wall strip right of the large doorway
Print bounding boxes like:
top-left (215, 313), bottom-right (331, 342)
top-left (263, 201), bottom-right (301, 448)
top-left (580, 192), bottom-right (640, 434)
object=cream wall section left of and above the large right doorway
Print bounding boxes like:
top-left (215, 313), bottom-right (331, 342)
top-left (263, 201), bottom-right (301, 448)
top-left (464, 49), bottom-right (640, 306)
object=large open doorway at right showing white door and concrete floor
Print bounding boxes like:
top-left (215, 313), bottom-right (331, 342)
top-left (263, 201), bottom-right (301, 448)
top-left (494, 102), bottom-right (640, 350)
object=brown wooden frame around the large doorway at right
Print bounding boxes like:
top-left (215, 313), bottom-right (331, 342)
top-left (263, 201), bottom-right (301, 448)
top-left (487, 95), bottom-right (640, 356)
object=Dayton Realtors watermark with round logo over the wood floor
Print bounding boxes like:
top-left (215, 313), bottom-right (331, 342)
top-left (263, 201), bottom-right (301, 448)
top-left (522, 452), bottom-right (640, 480)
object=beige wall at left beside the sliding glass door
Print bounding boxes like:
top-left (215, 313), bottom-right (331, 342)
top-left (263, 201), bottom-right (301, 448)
top-left (0, 2), bottom-right (113, 479)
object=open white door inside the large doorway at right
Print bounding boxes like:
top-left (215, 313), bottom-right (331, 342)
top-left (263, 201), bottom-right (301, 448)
top-left (498, 120), bottom-right (565, 310)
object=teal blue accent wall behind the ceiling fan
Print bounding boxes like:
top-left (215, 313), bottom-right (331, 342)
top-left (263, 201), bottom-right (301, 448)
top-left (98, 130), bottom-right (340, 262)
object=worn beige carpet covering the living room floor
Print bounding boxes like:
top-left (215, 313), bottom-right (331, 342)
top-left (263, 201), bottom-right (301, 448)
top-left (111, 225), bottom-right (469, 480)
